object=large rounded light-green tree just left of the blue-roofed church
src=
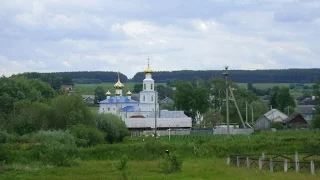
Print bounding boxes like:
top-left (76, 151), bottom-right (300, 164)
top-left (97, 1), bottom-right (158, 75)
top-left (50, 94), bottom-right (95, 129)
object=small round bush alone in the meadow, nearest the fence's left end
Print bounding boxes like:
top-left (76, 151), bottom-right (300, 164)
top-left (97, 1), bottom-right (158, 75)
top-left (160, 153), bottom-right (182, 173)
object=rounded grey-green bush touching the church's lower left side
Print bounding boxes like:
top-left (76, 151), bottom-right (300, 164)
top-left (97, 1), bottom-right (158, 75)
top-left (96, 114), bottom-right (128, 143)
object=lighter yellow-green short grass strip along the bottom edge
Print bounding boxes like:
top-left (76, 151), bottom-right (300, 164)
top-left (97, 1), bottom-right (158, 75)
top-left (0, 158), bottom-right (318, 180)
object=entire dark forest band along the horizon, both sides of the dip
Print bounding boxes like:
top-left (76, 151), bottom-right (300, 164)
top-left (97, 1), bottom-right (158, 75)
top-left (13, 69), bottom-right (320, 86)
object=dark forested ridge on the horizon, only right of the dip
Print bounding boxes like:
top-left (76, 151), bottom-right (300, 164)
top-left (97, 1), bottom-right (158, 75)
top-left (131, 69), bottom-right (320, 83)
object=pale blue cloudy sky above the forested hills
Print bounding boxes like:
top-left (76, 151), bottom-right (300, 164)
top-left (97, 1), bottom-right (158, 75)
top-left (0, 0), bottom-right (320, 78)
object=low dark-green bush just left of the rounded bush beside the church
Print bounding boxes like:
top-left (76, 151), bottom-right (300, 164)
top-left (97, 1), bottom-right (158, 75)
top-left (71, 124), bottom-right (104, 147)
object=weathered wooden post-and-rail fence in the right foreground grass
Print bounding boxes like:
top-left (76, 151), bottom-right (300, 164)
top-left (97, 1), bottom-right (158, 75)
top-left (227, 152), bottom-right (320, 174)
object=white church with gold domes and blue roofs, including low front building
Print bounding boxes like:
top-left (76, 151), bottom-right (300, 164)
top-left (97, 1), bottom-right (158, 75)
top-left (99, 62), bottom-right (192, 130)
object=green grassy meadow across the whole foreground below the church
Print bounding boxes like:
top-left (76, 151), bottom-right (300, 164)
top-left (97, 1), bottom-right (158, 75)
top-left (0, 131), bottom-right (320, 180)
